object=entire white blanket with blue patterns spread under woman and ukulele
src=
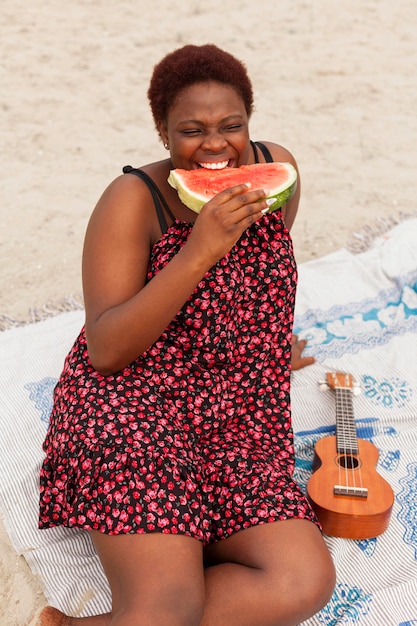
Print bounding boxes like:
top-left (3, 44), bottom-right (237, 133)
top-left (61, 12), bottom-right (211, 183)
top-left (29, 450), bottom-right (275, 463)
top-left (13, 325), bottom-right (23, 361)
top-left (0, 219), bottom-right (417, 626)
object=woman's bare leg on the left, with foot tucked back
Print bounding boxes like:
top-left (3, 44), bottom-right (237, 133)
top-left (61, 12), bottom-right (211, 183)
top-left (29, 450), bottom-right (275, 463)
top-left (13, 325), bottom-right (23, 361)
top-left (37, 532), bottom-right (204, 626)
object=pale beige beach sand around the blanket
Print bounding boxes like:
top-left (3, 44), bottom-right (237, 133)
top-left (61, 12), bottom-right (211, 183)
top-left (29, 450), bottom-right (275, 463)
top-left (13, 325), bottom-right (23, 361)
top-left (0, 0), bottom-right (417, 626)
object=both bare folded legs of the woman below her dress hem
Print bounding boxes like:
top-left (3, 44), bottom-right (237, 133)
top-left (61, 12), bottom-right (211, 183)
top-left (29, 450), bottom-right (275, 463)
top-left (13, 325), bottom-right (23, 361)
top-left (39, 520), bottom-right (335, 626)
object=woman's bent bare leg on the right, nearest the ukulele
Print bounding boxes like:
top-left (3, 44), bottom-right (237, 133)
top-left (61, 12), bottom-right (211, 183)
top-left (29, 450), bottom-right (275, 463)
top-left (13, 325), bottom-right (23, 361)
top-left (201, 520), bottom-right (335, 626)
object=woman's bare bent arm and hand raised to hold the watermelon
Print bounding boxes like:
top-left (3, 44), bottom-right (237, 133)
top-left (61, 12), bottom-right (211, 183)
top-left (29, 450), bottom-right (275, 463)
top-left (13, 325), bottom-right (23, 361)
top-left (83, 175), bottom-right (266, 374)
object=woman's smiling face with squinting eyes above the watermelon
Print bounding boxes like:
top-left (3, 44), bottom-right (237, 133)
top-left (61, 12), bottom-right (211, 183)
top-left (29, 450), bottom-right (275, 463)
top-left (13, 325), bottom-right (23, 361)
top-left (160, 81), bottom-right (251, 170)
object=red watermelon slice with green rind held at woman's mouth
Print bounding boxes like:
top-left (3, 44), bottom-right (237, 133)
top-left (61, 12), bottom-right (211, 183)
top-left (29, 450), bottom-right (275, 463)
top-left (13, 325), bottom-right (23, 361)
top-left (168, 163), bottom-right (297, 213)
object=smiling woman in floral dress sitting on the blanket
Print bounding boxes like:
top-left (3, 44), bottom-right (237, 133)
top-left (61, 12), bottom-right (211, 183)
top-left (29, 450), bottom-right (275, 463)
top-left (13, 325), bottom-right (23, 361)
top-left (40, 45), bottom-right (334, 626)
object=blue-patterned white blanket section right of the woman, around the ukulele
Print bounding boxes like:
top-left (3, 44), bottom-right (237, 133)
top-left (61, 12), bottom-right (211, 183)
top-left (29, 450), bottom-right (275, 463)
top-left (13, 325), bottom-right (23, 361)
top-left (292, 220), bottom-right (417, 626)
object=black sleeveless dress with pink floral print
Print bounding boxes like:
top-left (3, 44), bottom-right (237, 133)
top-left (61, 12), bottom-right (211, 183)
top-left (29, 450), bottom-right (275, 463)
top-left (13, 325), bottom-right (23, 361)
top-left (39, 212), bottom-right (316, 544)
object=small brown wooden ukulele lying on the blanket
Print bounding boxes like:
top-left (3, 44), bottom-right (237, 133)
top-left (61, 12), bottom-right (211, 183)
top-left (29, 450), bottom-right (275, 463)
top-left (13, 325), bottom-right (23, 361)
top-left (307, 372), bottom-right (394, 539)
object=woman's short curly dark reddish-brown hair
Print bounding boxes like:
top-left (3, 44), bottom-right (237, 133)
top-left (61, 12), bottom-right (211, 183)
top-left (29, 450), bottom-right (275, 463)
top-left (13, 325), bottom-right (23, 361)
top-left (148, 44), bottom-right (253, 128)
